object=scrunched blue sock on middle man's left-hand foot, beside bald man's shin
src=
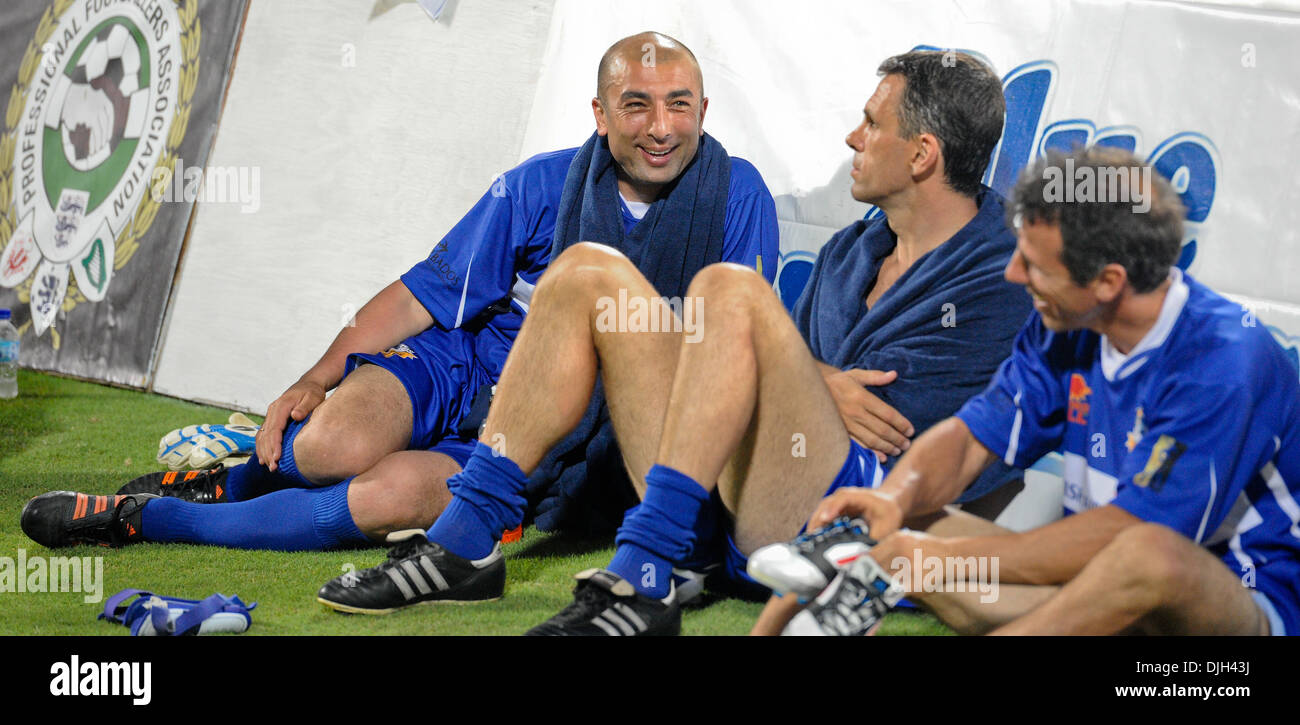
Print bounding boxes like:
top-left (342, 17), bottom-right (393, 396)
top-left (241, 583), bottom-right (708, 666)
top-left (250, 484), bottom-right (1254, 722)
top-left (429, 443), bottom-right (528, 559)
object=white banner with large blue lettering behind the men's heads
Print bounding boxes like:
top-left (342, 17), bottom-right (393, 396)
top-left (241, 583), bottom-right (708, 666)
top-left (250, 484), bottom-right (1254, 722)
top-left (524, 0), bottom-right (1300, 371)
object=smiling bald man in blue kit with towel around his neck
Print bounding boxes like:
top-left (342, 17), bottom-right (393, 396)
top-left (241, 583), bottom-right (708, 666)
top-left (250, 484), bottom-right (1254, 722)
top-left (22, 32), bottom-right (779, 553)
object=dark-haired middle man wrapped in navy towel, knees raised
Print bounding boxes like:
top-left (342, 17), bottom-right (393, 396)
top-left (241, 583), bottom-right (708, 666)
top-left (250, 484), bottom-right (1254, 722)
top-left (309, 53), bottom-right (1028, 635)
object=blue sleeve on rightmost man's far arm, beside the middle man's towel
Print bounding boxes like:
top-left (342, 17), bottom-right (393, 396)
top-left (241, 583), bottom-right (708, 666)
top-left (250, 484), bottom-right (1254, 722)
top-left (957, 319), bottom-right (1066, 468)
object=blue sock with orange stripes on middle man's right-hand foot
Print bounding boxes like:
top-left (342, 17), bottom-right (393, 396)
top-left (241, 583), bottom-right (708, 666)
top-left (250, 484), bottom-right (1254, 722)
top-left (610, 465), bottom-right (710, 599)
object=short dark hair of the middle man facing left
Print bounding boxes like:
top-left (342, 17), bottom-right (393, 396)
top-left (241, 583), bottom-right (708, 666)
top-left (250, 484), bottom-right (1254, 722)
top-left (876, 51), bottom-right (1006, 196)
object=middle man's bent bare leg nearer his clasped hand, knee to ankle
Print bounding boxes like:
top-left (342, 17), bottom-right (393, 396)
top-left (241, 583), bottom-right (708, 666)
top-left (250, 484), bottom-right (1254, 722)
top-left (657, 264), bottom-right (849, 553)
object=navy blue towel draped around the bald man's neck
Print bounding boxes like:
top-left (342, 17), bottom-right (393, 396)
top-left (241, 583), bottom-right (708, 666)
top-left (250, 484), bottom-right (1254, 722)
top-left (527, 134), bottom-right (731, 531)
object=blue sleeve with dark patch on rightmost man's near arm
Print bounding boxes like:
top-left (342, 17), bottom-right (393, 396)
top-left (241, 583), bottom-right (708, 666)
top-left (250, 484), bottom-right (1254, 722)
top-left (1112, 377), bottom-right (1273, 543)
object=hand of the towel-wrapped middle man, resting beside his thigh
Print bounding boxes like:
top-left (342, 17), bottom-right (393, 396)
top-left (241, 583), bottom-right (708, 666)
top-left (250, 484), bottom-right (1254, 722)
top-left (823, 368), bottom-right (917, 463)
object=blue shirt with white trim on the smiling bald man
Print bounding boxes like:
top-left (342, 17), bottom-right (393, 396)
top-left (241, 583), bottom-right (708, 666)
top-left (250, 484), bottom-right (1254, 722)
top-left (402, 148), bottom-right (780, 374)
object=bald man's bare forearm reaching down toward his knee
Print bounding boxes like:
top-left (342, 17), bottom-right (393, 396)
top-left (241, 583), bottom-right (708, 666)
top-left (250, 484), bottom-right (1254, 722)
top-left (302, 281), bottom-right (433, 390)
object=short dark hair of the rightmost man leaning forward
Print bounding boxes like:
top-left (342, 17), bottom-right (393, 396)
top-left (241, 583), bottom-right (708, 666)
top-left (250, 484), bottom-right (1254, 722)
top-left (1006, 146), bottom-right (1186, 292)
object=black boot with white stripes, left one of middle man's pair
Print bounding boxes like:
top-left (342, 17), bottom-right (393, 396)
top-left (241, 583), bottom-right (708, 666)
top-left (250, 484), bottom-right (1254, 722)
top-left (316, 529), bottom-right (506, 615)
